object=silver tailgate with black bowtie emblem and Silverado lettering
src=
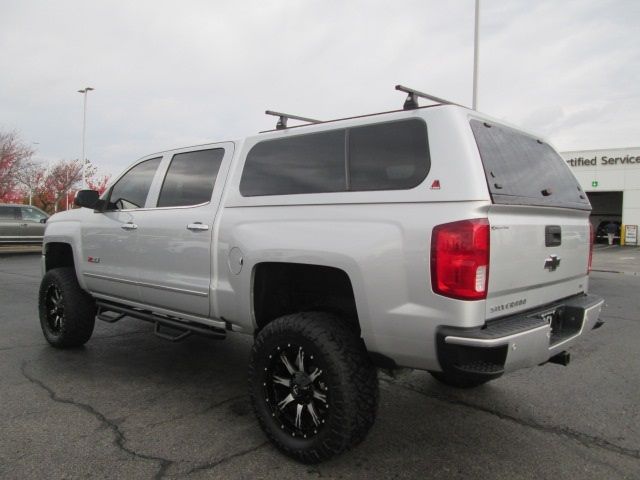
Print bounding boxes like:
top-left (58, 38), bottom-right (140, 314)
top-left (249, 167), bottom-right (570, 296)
top-left (486, 205), bottom-right (589, 319)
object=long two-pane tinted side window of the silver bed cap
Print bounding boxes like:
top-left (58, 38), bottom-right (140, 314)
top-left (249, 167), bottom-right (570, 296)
top-left (240, 119), bottom-right (430, 196)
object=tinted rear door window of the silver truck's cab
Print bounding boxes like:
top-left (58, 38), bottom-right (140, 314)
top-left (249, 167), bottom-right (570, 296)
top-left (158, 148), bottom-right (224, 207)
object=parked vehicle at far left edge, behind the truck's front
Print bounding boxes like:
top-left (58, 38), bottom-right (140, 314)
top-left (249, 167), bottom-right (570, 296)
top-left (0, 204), bottom-right (49, 243)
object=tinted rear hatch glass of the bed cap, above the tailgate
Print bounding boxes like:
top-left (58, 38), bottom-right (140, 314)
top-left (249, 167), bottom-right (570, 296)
top-left (471, 120), bottom-right (591, 210)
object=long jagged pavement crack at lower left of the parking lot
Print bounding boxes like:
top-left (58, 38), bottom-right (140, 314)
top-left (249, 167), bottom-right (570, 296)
top-left (20, 362), bottom-right (175, 478)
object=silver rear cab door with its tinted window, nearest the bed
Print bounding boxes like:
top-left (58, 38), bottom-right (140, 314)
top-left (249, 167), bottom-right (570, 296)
top-left (136, 143), bottom-right (233, 317)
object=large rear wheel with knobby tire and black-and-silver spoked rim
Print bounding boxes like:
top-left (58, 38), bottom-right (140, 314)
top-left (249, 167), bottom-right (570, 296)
top-left (249, 312), bottom-right (378, 463)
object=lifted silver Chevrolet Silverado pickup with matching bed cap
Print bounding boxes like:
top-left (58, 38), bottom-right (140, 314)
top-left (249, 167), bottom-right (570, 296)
top-left (39, 89), bottom-right (603, 463)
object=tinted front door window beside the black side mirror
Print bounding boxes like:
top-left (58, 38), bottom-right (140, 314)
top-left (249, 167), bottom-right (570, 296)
top-left (109, 157), bottom-right (162, 210)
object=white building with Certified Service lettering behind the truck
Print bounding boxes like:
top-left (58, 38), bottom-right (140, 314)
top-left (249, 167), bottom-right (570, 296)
top-left (561, 147), bottom-right (640, 245)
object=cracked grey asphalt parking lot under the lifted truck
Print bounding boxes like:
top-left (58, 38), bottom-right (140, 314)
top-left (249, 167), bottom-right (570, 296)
top-left (0, 246), bottom-right (640, 480)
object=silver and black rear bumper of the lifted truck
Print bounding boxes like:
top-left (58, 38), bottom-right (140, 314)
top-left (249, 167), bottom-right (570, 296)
top-left (437, 294), bottom-right (604, 378)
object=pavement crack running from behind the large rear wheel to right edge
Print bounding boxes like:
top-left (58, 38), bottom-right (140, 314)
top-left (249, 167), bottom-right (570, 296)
top-left (381, 379), bottom-right (640, 459)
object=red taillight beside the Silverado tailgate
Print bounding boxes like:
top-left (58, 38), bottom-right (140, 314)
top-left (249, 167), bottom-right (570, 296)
top-left (431, 218), bottom-right (489, 300)
